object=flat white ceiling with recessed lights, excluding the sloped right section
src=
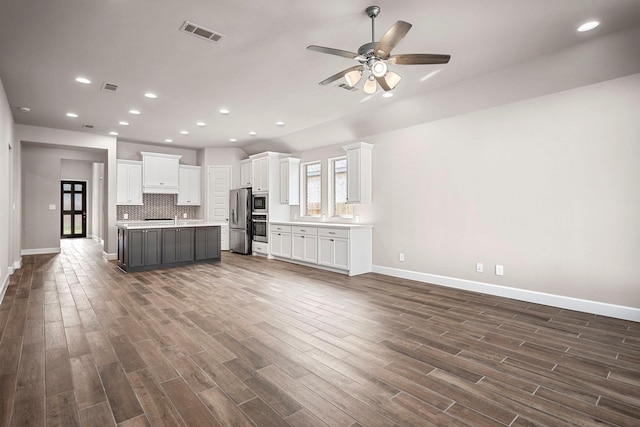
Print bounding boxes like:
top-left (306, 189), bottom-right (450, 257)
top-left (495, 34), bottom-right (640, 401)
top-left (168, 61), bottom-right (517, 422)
top-left (0, 0), bottom-right (640, 153)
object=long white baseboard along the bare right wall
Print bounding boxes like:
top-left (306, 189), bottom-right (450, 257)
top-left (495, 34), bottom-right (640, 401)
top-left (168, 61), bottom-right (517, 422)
top-left (372, 265), bottom-right (640, 322)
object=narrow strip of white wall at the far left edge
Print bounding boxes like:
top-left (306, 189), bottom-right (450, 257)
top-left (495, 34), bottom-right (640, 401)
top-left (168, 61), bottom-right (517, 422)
top-left (0, 80), bottom-right (15, 301)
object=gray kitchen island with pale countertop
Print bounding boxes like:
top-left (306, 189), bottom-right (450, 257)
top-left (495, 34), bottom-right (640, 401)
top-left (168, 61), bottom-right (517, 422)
top-left (116, 220), bottom-right (224, 272)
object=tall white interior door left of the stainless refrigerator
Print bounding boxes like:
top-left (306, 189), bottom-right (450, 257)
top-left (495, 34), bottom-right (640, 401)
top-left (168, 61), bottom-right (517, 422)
top-left (207, 166), bottom-right (231, 251)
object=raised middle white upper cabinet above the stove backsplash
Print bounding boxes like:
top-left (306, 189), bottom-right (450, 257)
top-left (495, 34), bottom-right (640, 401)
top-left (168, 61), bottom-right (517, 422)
top-left (140, 151), bottom-right (182, 194)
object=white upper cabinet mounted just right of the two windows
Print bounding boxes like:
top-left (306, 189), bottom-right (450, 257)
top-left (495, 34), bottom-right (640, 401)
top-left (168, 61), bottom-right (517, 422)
top-left (342, 142), bottom-right (373, 203)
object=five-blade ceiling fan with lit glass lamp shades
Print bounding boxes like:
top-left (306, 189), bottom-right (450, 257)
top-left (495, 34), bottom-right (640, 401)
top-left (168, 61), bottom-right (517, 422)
top-left (307, 6), bottom-right (451, 95)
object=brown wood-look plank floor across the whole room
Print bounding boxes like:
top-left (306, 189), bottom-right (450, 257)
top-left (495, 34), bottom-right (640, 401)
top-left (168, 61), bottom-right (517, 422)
top-left (0, 239), bottom-right (640, 426)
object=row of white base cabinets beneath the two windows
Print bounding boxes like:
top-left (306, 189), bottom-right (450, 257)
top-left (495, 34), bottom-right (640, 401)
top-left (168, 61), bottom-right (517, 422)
top-left (270, 222), bottom-right (372, 276)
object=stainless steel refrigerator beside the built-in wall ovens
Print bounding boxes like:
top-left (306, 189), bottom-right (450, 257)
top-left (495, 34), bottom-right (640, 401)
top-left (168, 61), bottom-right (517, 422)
top-left (229, 188), bottom-right (251, 254)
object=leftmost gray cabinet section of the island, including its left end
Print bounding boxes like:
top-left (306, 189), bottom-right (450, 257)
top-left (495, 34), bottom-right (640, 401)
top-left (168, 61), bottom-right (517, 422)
top-left (118, 229), bottom-right (162, 270)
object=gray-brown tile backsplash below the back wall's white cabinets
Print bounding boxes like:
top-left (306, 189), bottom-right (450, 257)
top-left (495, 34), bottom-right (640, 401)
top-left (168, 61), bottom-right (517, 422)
top-left (116, 194), bottom-right (200, 221)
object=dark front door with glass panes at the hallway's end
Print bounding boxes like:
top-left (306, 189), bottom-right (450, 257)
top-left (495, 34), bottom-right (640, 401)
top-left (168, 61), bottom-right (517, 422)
top-left (60, 181), bottom-right (87, 238)
